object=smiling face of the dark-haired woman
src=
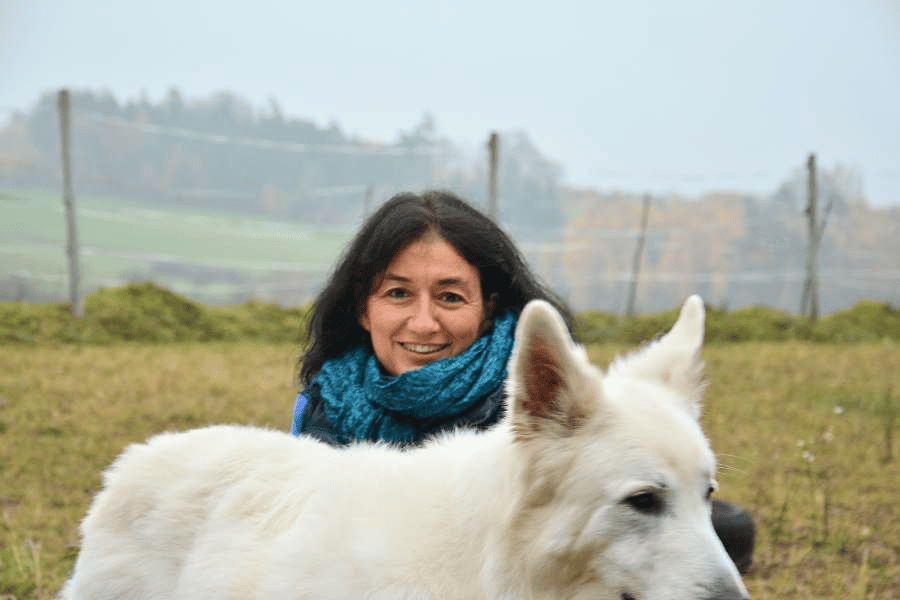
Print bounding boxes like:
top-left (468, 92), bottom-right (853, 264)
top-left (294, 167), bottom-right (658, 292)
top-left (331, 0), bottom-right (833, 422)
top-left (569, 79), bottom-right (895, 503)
top-left (359, 232), bottom-right (485, 375)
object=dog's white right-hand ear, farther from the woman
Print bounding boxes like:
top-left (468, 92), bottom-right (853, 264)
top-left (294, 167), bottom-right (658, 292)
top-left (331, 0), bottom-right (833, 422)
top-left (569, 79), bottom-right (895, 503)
top-left (609, 296), bottom-right (706, 418)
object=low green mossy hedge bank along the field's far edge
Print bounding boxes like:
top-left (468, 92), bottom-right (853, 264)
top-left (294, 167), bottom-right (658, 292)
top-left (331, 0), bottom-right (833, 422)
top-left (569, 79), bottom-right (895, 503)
top-left (0, 283), bottom-right (900, 344)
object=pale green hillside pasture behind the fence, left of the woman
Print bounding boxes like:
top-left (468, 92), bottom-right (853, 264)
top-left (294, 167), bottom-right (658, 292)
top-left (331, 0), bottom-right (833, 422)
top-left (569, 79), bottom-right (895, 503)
top-left (0, 189), bottom-right (352, 298)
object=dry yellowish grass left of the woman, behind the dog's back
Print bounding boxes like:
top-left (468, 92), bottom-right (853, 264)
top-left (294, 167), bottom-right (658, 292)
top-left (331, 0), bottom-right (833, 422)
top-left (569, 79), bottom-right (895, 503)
top-left (0, 343), bottom-right (298, 599)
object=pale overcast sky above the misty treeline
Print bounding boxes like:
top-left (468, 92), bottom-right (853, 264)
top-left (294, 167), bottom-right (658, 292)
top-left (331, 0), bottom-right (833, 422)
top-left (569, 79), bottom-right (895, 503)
top-left (0, 0), bottom-right (900, 205)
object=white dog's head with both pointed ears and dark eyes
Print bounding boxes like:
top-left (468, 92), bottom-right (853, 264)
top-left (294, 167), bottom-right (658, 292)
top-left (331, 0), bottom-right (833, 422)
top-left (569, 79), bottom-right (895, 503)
top-left (507, 296), bottom-right (747, 600)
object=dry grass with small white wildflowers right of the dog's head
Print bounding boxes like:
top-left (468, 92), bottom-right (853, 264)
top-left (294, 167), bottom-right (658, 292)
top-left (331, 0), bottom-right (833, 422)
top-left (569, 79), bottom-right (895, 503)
top-left (590, 341), bottom-right (900, 600)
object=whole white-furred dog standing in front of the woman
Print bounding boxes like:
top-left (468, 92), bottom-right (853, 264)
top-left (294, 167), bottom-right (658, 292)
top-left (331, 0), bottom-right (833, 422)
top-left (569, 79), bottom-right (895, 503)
top-left (62, 296), bottom-right (747, 600)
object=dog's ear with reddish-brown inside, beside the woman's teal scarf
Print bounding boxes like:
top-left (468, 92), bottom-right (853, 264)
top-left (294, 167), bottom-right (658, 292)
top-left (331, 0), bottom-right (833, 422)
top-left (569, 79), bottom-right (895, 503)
top-left (507, 300), bottom-right (593, 439)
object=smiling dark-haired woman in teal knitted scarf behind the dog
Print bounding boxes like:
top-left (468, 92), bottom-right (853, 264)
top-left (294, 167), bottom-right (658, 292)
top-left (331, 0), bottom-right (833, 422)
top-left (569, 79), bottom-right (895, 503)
top-left (293, 191), bottom-right (572, 445)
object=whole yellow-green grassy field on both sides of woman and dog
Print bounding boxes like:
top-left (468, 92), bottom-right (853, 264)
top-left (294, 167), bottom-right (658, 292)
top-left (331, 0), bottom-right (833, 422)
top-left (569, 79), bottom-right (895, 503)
top-left (0, 341), bottom-right (900, 600)
